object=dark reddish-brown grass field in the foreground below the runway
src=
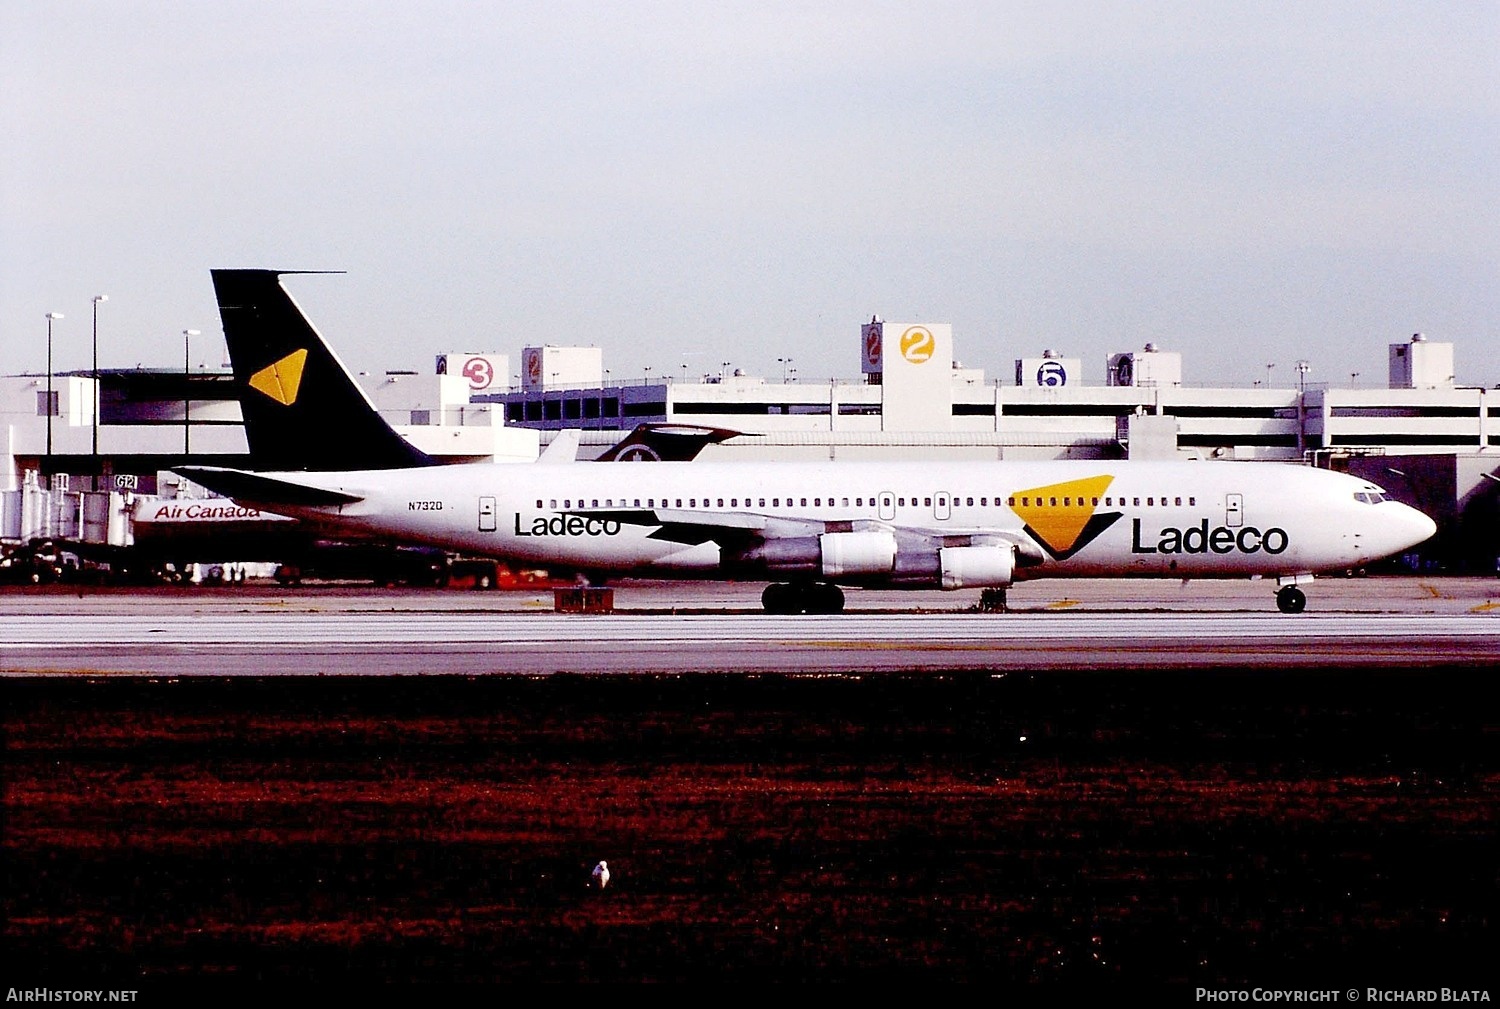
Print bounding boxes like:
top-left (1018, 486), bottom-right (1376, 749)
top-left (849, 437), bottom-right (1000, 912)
top-left (0, 669), bottom-right (1500, 997)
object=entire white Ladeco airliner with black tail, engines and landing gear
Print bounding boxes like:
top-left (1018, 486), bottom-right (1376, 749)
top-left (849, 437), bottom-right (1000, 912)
top-left (179, 270), bottom-right (1436, 613)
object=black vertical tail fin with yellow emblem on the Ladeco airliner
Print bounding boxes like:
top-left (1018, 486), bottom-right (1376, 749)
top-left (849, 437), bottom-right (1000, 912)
top-left (213, 270), bottom-right (438, 472)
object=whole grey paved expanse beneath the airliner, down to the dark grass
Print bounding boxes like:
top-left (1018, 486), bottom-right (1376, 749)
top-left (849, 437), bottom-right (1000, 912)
top-left (0, 576), bottom-right (1500, 676)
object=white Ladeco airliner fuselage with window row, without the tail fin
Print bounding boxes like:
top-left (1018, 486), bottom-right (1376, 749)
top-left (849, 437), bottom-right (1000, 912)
top-left (237, 460), bottom-right (1433, 588)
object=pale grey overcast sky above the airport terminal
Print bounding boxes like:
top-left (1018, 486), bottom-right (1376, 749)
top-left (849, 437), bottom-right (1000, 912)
top-left (0, 0), bottom-right (1500, 385)
